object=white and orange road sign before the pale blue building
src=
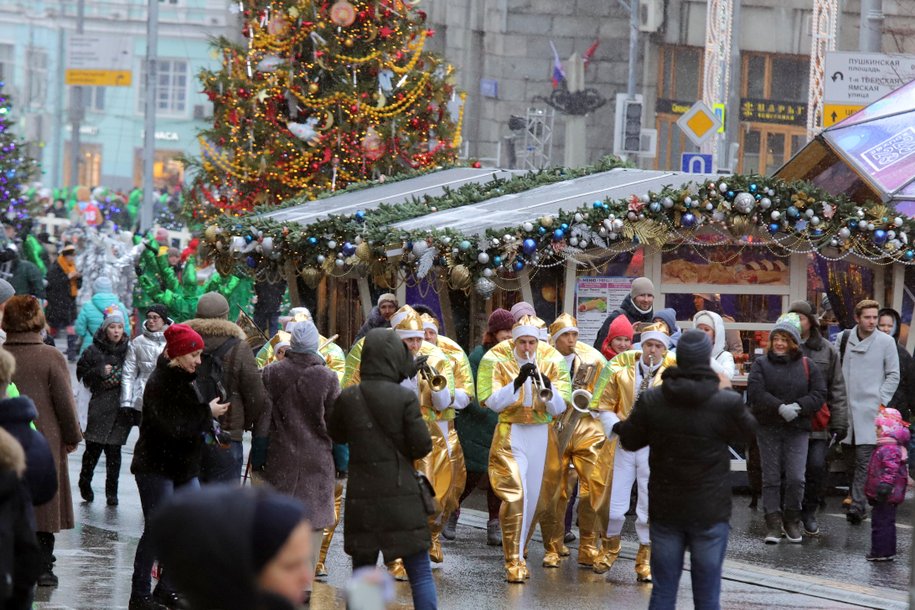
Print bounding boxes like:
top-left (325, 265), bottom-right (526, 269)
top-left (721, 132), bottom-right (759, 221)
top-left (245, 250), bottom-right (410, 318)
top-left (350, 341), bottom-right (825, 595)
top-left (64, 34), bottom-right (134, 87)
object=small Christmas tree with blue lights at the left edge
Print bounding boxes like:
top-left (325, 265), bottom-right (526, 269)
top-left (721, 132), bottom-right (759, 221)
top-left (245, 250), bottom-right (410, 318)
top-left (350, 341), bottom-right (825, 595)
top-left (0, 82), bottom-right (39, 226)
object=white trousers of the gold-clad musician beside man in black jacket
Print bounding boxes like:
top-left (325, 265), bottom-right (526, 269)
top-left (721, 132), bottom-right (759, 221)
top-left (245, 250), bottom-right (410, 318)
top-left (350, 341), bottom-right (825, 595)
top-left (607, 445), bottom-right (650, 544)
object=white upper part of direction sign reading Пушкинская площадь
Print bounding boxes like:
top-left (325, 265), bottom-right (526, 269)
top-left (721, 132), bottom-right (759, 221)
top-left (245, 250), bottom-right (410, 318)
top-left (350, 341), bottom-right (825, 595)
top-left (823, 51), bottom-right (915, 106)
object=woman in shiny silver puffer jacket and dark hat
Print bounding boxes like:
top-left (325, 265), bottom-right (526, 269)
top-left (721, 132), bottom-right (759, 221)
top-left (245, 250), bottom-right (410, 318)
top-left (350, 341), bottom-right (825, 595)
top-left (121, 303), bottom-right (172, 414)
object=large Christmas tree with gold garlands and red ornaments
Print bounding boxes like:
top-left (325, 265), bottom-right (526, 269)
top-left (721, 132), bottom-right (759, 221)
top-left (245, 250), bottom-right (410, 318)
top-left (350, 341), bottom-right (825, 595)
top-left (189, 0), bottom-right (463, 215)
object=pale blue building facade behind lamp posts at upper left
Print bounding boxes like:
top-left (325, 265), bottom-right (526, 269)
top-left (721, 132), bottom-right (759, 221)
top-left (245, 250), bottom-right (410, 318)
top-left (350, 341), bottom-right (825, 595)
top-left (0, 0), bottom-right (239, 189)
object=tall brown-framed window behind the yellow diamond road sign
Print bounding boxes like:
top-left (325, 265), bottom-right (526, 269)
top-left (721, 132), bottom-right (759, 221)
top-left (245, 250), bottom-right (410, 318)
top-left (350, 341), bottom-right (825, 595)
top-left (655, 45), bottom-right (704, 169)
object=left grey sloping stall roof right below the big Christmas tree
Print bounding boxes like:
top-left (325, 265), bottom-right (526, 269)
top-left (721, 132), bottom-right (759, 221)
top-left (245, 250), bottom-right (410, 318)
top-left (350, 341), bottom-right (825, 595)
top-left (260, 167), bottom-right (525, 225)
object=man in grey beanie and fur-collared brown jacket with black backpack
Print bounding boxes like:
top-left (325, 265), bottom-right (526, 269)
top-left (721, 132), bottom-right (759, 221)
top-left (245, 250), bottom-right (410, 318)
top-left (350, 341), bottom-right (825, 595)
top-left (186, 292), bottom-right (267, 484)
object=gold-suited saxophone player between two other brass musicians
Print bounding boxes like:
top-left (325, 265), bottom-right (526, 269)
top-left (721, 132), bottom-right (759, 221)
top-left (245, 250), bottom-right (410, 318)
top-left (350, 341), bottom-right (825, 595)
top-left (540, 314), bottom-right (609, 568)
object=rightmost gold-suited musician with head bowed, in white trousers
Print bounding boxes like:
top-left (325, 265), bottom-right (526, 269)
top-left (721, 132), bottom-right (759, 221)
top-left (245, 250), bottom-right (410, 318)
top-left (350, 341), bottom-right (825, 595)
top-left (590, 324), bottom-right (676, 582)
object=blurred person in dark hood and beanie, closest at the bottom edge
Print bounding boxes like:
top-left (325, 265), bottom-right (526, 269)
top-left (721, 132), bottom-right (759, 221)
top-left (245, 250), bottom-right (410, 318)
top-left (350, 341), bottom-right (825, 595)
top-left (149, 485), bottom-right (314, 610)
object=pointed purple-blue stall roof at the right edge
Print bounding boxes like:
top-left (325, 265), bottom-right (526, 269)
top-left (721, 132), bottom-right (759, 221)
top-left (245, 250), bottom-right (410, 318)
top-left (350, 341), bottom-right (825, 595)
top-left (775, 81), bottom-right (915, 216)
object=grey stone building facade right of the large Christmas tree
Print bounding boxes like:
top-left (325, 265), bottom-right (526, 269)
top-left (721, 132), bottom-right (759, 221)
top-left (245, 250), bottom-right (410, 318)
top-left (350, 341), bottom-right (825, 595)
top-left (428, 0), bottom-right (915, 174)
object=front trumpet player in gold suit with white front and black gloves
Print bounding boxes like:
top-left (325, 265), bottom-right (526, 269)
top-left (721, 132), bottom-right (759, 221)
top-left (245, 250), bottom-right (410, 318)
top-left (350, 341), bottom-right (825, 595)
top-left (477, 316), bottom-right (571, 583)
